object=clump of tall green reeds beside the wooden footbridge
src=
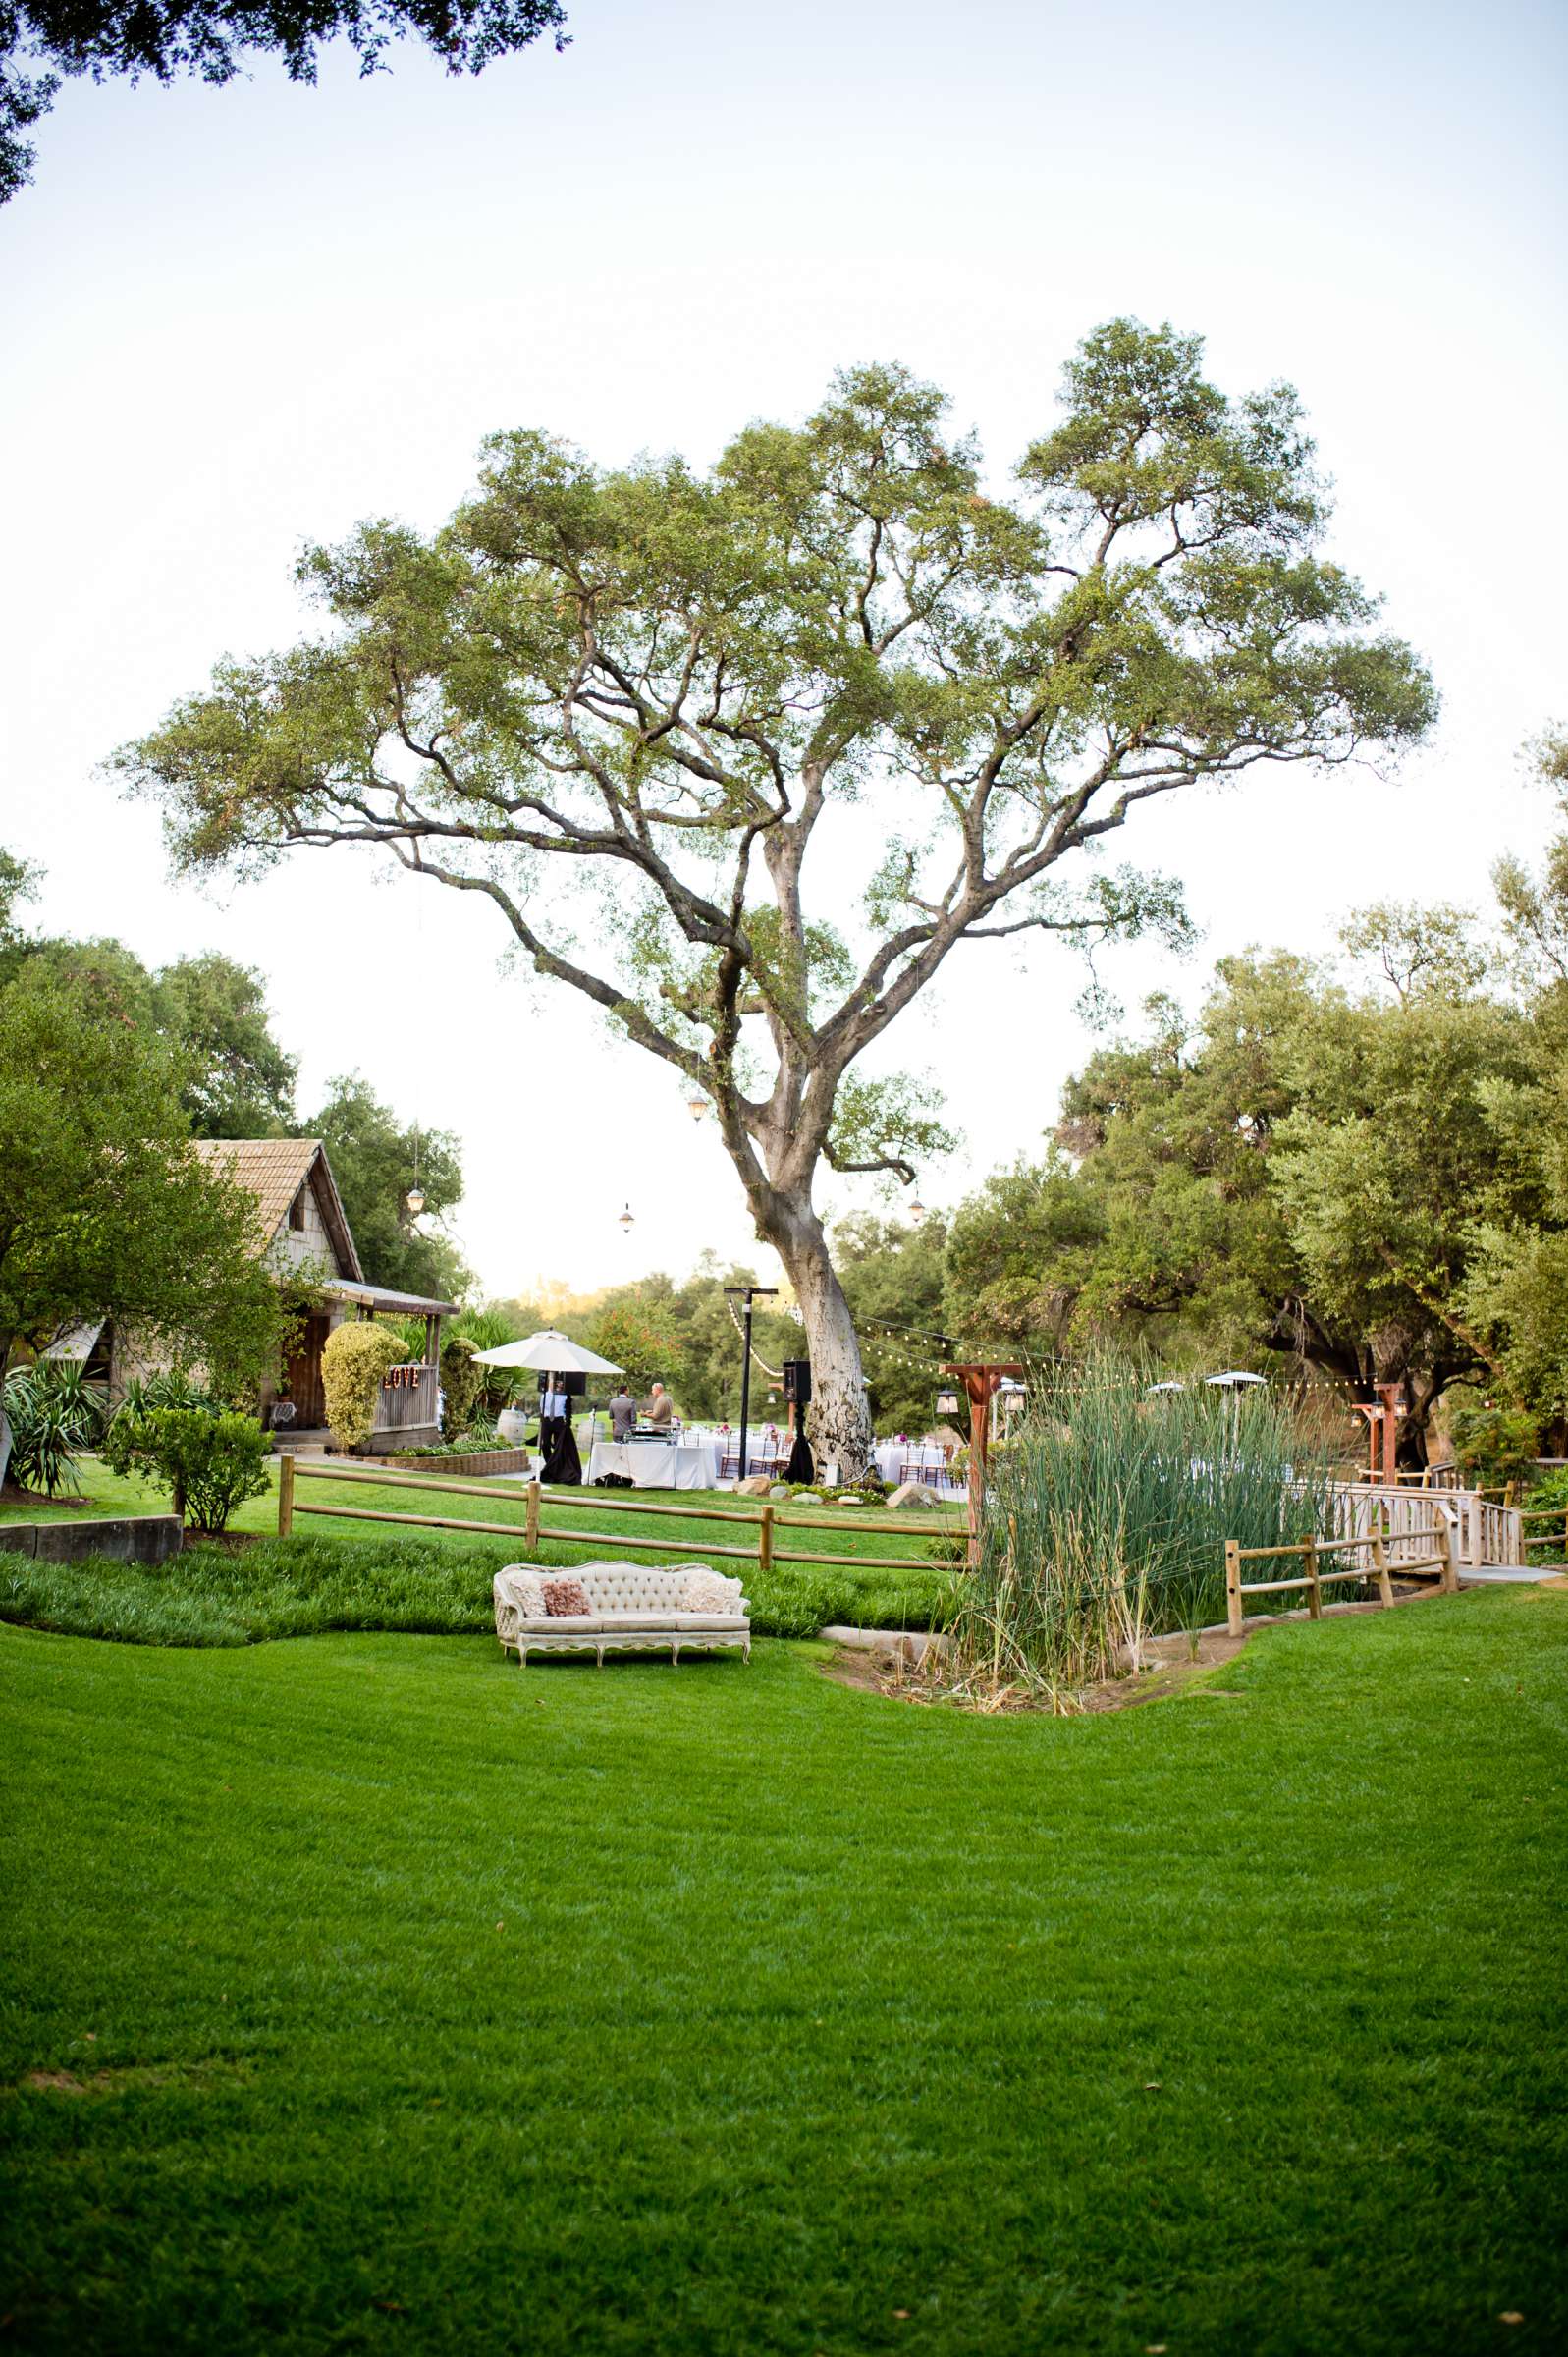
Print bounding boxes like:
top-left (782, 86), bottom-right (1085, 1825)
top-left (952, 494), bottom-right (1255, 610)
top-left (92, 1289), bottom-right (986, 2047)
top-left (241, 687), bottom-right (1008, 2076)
top-left (952, 1353), bottom-right (1332, 1707)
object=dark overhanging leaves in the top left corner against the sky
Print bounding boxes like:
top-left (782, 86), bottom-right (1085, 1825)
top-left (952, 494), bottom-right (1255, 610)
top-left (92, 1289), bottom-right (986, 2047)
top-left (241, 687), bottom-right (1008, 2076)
top-left (0, 0), bottom-right (566, 205)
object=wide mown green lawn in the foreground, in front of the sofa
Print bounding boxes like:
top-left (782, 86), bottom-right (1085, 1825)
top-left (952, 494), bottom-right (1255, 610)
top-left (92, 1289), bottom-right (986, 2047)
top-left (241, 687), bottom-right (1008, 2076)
top-left (0, 1589), bottom-right (1568, 2357)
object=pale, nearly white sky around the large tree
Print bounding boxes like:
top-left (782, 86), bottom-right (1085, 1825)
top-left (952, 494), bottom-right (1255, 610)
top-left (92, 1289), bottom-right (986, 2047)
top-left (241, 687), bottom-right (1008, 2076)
top-left (0, 0), bottom-right (1568, 1294)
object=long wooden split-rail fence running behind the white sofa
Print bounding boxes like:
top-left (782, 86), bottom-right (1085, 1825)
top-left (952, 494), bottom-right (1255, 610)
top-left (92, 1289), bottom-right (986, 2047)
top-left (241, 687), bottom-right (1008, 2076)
top-left (278, 1454), bottom-right (962, 1572)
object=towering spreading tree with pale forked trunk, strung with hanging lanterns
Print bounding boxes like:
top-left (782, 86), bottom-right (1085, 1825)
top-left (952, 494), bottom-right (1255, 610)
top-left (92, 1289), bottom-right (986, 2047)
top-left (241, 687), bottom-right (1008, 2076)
top-left (120, 320), bottom-right (1433, 1475)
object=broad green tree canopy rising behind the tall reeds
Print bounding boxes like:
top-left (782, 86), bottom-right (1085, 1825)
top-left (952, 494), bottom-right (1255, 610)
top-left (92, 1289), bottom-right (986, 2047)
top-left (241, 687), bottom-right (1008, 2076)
top-left (947, 905), bottom-right (1561, 1454)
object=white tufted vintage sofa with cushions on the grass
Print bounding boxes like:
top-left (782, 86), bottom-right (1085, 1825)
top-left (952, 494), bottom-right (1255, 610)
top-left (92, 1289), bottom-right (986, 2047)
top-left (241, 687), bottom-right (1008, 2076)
top-left (495, 1562), bottom-right (752, 1669)
